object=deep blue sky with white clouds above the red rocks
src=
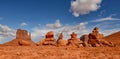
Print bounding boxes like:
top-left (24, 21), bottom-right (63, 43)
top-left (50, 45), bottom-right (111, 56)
top-left (0, 0), bottom-right (120, 43)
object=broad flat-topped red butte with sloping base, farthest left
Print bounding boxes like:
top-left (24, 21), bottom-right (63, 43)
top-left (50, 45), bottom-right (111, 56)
top-left (3, 29), bottom-right (36, 46)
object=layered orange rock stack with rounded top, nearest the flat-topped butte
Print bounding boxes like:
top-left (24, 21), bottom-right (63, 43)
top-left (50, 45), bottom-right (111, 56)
top-left (37, 31), bottom-right (56, 46)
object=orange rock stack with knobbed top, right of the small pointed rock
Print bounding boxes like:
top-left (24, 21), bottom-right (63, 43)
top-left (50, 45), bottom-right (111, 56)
top-left (68, 32), bottom-right (83, 47)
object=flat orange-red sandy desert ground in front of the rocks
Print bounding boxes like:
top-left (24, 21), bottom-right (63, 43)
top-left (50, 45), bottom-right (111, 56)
top-left (0, 46), bottom-right (120, 59)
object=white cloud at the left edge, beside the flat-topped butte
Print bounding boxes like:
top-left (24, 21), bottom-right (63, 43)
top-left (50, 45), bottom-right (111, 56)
top-left (0, 24), bottom-right (15, 40)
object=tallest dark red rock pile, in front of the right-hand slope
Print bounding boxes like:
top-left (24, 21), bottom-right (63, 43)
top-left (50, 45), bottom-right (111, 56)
top-left (89, 27), bottom-right (114, 47)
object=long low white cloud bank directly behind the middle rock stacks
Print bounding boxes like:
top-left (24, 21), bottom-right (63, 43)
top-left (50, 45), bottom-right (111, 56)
top-left (31, 22), bottom-right (89, 41)
